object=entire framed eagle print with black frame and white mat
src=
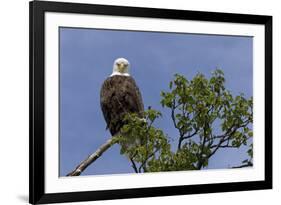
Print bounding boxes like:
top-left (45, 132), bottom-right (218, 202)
top-left (30, 1), bottom-right (272, 204)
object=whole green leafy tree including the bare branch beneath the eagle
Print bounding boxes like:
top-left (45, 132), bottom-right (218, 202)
top-left (66, 70), bottom-right (253, 176)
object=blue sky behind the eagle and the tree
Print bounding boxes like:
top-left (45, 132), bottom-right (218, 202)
top-left (59, 28), bottom-right (253, 176)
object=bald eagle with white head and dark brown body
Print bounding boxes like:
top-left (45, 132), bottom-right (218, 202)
top-left (100, 58), bottom-right (144, 136)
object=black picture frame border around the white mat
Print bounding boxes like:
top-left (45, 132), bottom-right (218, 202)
top-left (29, 1), bottom-right (272, 204)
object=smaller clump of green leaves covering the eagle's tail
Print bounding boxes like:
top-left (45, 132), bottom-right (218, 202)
top-left (116, 109), bottom-right (167, 172)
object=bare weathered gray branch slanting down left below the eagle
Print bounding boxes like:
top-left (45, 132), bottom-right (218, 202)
top-left (66, 135), bottom-right (117, 176)
